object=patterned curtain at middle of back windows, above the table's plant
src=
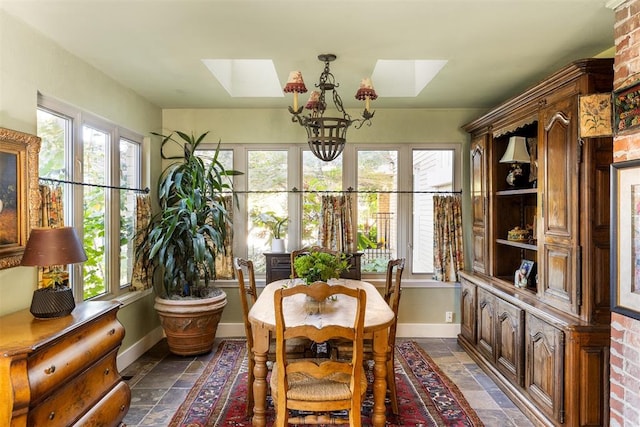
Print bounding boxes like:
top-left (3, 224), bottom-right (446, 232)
top-left (320, 194), bottom-right (356, 253)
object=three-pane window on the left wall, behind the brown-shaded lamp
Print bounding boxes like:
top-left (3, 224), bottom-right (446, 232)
top-left (37, 97), bottom-right (142, 300)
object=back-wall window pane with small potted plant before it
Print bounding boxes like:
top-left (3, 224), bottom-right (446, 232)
top-left (247, 150), bottom-right (288, 272)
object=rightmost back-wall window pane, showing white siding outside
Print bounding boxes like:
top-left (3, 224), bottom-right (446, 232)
top-left (412, 150), bottom-right (454, 273)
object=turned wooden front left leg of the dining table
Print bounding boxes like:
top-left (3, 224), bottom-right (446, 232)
top-left (248, 325), bottom-right (269, 427)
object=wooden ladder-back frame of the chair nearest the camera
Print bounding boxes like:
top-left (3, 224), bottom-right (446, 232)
top-left (274, 282), bottom-right (367, 425)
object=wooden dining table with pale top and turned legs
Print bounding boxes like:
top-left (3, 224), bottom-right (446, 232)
top-left (248, 279), bottom-right (394, 427)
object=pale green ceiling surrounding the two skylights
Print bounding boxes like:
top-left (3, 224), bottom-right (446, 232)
top-left (0, 0), bottom-right (614, 109)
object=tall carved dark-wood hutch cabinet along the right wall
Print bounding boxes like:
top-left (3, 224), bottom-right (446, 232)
top-left (459, 59), bottom-right (613, 426)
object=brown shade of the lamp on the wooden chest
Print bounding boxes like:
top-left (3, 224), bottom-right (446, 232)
top-left (20, 227), bottom-right (87, 267)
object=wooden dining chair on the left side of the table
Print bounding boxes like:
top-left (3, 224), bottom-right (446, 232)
top-left (233, 257), bottom-right (311, 417)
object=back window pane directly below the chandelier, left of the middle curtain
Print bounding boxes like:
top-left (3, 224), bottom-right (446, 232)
top-left (302, 150), bottom-right (342, 247)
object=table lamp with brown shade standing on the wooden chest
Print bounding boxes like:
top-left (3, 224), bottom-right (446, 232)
top-left (20, 227), bottom-right (87, 319)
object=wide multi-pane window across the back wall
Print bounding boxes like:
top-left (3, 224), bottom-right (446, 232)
top-left (199, 144), bottom-right (462, 279)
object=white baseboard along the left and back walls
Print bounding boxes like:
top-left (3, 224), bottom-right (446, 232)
top-left (118, 323), bottom-right (460, 371)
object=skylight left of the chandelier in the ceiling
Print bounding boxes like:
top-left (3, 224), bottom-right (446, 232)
top-left (202, 59), bottom-right (284, 98)
